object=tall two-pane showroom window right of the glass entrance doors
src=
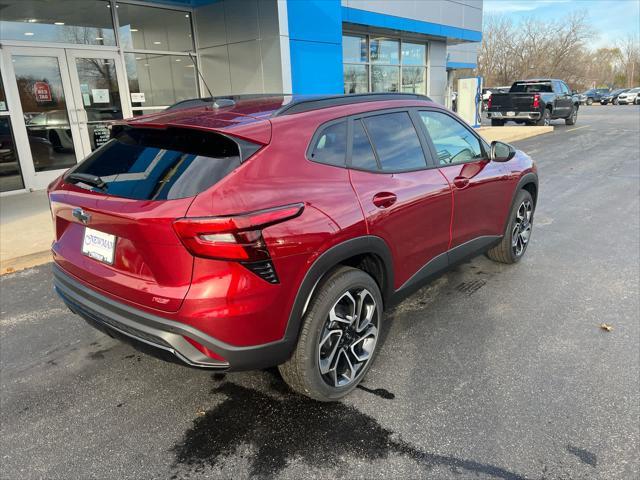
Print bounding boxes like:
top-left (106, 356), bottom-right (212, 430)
top-left (117, 2), bottom-right (198, 115)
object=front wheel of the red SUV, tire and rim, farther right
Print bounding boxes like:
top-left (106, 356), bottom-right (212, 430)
top-left (486, 190), bottom-right (535, 264)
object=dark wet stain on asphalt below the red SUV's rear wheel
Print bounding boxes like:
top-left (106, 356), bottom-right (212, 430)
top-left (172, 374), bottom-right (525, 480)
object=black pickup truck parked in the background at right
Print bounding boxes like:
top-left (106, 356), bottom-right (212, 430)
top-left (487, 79), bottom-right (580, 127)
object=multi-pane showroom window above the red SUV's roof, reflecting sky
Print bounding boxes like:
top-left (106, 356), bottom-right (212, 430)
top-left (342, 34), bottom-right (427, 95)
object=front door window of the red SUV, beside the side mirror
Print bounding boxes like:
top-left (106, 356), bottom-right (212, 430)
top-left (420, 112), bottom-right (484, 165)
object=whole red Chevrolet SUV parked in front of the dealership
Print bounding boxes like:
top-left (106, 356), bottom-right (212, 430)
top-left (49, 94), bottom-right (538, 401)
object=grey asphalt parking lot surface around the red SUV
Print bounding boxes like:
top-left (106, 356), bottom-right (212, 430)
top-left (0, 106), bottom-right (640, 479)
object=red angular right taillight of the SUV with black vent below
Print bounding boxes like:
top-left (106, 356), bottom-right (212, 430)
top-left (173, 203), bottom-right (304, 283)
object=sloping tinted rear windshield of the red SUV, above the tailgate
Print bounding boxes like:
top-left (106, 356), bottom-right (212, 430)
top-left (65, 127), bottom-right (241, 200)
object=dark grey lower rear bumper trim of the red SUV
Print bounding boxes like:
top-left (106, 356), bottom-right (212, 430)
top-left (53, 264), bottom-right (291, 370)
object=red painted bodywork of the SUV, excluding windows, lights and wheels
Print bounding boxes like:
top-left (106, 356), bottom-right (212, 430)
top-left (49, 97), bottom-right (535, 366)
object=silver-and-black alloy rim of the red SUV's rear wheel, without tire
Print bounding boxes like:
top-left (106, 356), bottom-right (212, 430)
top-left (318, 288), bottom-right (379, 388)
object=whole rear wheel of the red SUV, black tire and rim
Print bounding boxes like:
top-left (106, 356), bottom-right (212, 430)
top-left (278, 267), bottom-right (383, 402)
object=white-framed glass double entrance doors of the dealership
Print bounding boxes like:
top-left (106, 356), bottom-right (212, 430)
top-left (2, 47), bottom-right (131, 189)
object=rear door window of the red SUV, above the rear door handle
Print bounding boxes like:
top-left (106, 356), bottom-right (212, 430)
top-left (363, 112), bottom-right (426, 171)
